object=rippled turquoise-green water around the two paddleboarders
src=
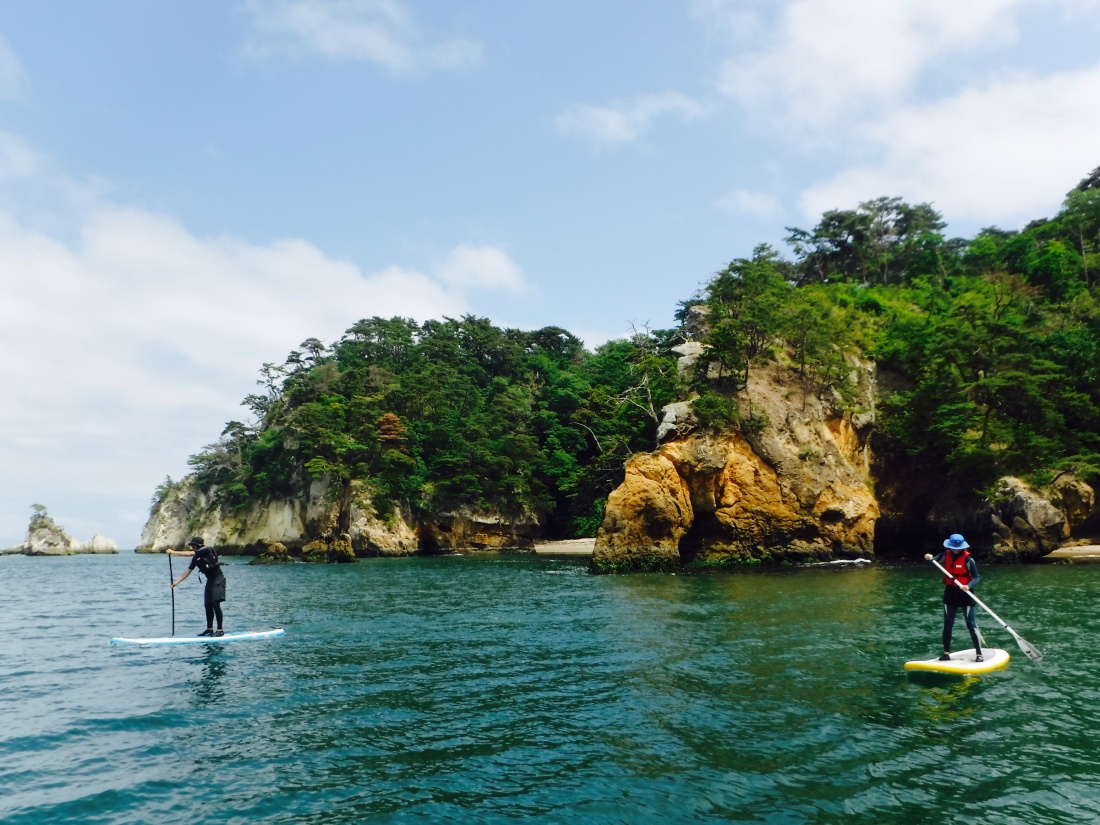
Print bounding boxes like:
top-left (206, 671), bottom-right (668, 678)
top-left (0, 553), bottom-right (1100, 825)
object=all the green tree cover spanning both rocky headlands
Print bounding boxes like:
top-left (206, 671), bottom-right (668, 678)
top-left (184, 180), bottom-right (1100, 545)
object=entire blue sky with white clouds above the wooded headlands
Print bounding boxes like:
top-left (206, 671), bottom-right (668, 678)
top-left (0, 0), bottom-right (1100, 549)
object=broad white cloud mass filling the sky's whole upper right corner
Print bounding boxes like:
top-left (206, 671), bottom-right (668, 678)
top-left (692, 0), bottom-right (1100, 227)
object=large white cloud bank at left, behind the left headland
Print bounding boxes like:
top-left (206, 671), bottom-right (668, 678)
top-left (0, 140), bottom-right (526, 547)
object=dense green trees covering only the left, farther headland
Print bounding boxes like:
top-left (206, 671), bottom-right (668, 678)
top-left (189, 316), bottom-right (680, 537)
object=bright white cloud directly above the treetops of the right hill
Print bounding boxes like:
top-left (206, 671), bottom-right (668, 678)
top-left (802, 68), bottom-right (1100, 226)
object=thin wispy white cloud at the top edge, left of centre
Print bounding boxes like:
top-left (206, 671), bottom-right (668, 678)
top-left (245, 0), bottom-right (482, 74)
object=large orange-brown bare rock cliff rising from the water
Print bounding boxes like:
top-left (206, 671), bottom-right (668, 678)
top-left (592, 361), bottom-right (879, 572)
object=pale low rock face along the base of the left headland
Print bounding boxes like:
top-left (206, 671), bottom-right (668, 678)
top-left (138, 477), bottom-right (538, 561)
